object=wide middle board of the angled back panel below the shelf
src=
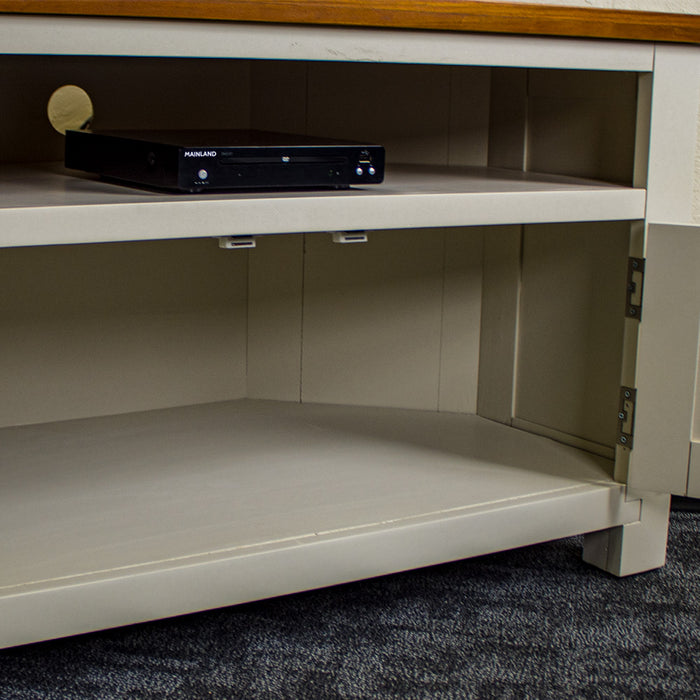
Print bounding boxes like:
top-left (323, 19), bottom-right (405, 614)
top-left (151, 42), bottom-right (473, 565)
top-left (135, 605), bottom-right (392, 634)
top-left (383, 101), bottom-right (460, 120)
top-left (302, 230), bottom-right (444, 410)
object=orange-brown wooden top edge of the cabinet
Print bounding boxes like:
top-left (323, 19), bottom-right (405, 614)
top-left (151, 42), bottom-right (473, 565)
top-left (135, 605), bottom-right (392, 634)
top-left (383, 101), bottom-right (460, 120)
top-left (0, 0), bottom-right (700, 44)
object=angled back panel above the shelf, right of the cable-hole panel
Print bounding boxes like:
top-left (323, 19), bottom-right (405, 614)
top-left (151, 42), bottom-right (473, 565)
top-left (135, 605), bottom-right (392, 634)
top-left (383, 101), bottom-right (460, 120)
top-left (251, 61), bottom-right (490, 165)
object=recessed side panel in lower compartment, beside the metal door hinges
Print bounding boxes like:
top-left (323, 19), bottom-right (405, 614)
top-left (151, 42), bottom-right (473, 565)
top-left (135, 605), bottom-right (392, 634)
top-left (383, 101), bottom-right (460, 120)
top-left (515, 222), bottom-right (629, 447)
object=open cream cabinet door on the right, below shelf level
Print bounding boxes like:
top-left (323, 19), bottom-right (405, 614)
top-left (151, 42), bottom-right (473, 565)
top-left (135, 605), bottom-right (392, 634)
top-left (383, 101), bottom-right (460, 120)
top-left (628, 224), bottom-right (700, 497)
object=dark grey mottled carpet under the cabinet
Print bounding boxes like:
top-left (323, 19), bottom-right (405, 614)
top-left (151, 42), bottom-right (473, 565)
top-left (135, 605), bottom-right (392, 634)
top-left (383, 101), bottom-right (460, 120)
top-left (0, 510), bottom-right (700, 700)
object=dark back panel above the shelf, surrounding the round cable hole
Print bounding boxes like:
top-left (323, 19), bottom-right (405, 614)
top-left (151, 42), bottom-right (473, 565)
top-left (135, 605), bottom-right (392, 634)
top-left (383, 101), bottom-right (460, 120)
top-left (0, 56), bottom-right (250, 162)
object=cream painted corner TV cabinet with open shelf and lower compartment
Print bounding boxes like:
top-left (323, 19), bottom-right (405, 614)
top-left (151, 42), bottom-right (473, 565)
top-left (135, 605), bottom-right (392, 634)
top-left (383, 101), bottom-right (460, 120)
top-left (0, 15), bottom-right (700, 646)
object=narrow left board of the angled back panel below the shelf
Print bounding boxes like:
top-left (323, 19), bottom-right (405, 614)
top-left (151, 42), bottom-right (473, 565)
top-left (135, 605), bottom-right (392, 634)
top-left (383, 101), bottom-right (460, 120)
top-left (248, 236), bottom-right (304, 401)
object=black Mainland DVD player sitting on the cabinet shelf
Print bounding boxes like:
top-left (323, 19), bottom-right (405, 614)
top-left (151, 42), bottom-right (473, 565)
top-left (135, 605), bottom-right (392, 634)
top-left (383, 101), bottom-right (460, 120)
top-left (65, 130), bottom-right (384, 192)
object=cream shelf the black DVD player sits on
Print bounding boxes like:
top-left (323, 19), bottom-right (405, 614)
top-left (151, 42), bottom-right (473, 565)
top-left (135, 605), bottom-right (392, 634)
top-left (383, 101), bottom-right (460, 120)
top-left (0, 165), bottom-right (646, 247)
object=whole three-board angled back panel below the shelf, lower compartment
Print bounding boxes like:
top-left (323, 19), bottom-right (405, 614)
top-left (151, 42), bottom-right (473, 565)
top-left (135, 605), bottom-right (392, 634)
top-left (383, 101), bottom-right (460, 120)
top-left (248, 228), bottom-right (484, 413)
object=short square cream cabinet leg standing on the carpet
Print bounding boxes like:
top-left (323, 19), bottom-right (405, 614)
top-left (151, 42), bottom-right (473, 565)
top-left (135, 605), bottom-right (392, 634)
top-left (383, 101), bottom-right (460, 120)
top-left (583, 494), bottom-right (671, 576)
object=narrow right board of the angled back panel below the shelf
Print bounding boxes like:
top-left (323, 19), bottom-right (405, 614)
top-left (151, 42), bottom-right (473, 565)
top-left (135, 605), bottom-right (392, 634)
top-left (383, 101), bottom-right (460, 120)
top-left (438, 227), bottom-right (484, 413)
